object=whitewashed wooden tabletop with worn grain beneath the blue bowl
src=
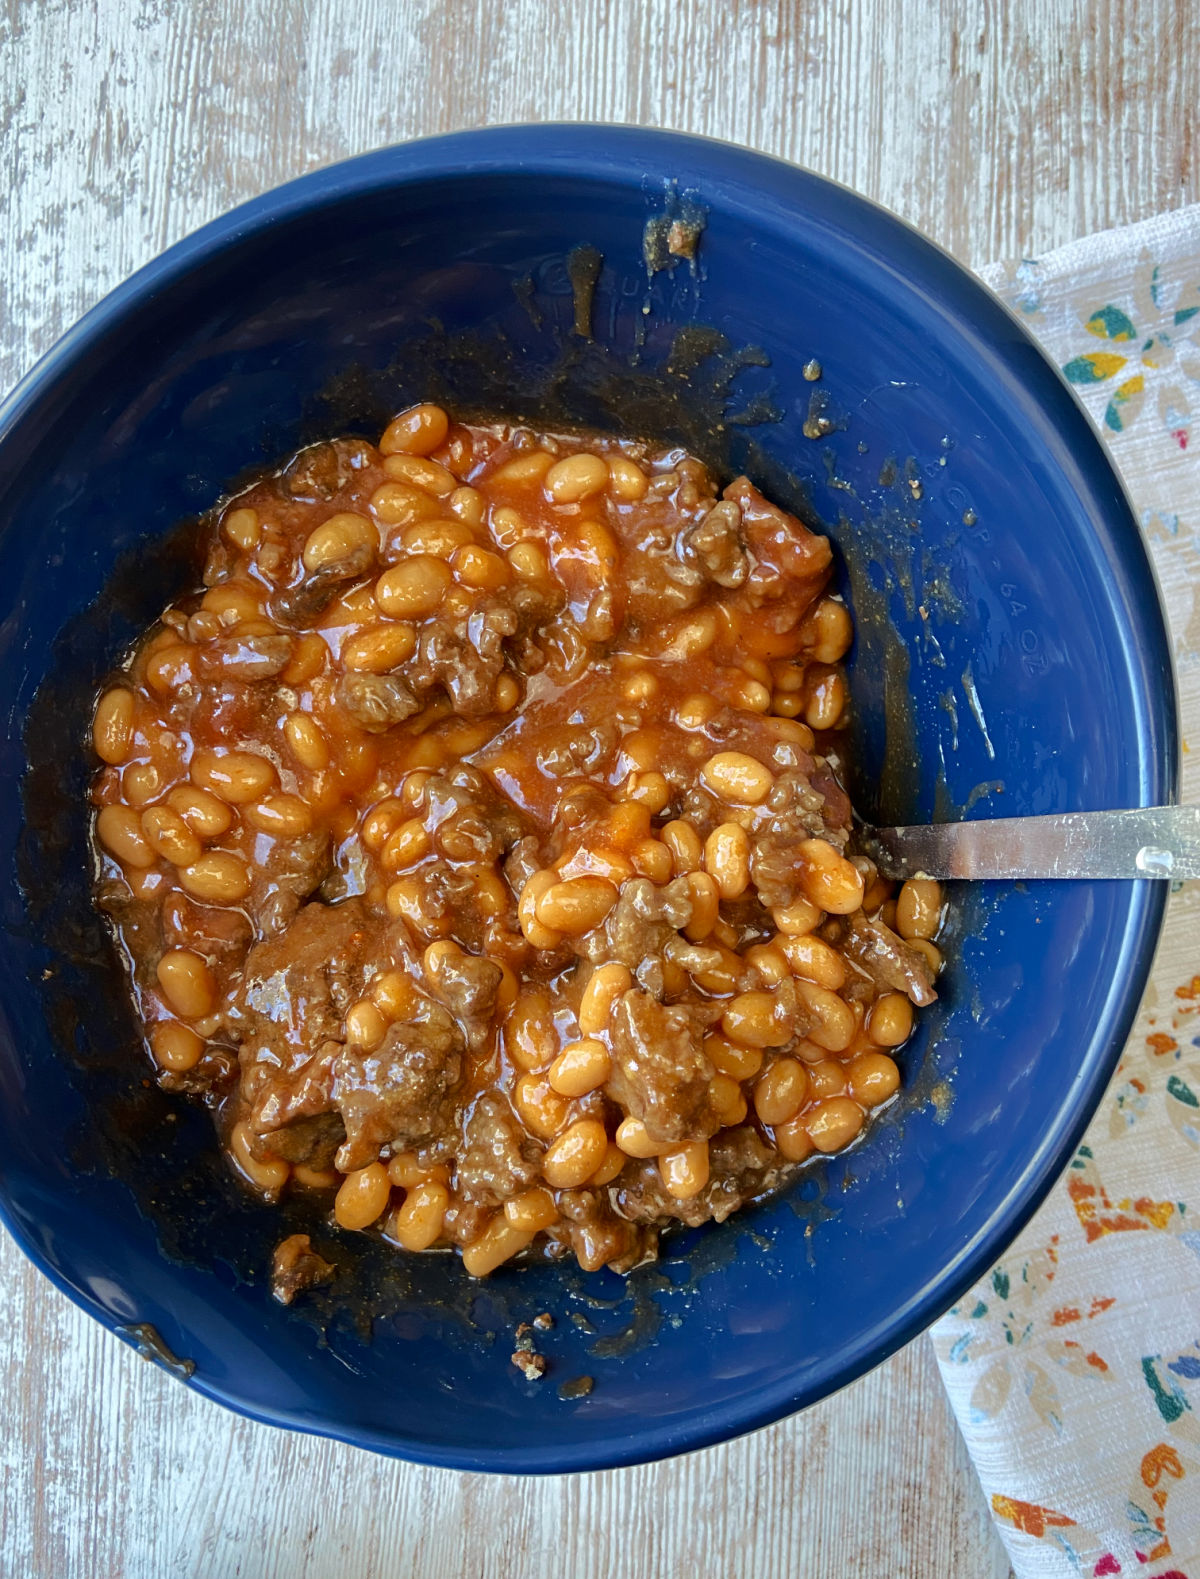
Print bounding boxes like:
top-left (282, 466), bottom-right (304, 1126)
top-left (0, 0), bottom-right (1200, 1579)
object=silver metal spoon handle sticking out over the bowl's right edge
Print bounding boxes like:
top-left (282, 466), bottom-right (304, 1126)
top-left (864, 805), bottom-right (1200, 880)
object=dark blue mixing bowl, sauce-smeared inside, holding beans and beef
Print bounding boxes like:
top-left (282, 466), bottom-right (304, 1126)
top-left (0, 126), bottom-right (1178, 1472)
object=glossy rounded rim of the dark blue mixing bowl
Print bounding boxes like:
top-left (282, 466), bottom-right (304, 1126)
top-left (0, 122), bottom-right (1179, 1473)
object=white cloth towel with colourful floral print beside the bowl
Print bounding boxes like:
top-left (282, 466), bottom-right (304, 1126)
top-left (933, 205), bottom-right (1200, 1579)
